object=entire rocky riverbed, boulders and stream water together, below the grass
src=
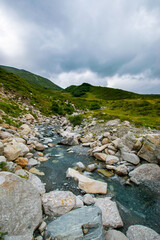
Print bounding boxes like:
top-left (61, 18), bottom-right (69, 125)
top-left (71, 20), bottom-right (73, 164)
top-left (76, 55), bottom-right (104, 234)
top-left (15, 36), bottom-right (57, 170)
top-left (0, 113), bottom-right (160, 240)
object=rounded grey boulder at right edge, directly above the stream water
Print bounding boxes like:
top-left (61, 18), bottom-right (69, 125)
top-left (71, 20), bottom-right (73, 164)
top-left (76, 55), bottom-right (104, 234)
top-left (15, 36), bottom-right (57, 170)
top-left (129, 163), bottom-right (160, 192)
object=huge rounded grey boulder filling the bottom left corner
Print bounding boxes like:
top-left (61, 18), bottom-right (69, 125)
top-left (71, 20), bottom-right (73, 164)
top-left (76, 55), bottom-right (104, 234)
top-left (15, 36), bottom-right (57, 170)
top-left (0, 172), bottom-right (42, 237)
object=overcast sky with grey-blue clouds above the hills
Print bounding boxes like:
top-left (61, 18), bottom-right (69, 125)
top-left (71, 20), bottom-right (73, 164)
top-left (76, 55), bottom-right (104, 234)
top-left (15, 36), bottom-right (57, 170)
top-left (0, 0), bottom-right (160, 93)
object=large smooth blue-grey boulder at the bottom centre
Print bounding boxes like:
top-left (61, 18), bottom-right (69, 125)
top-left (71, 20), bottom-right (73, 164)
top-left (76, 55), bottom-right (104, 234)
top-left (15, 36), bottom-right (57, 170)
top-left (45, 207), bottom-right (104, 240)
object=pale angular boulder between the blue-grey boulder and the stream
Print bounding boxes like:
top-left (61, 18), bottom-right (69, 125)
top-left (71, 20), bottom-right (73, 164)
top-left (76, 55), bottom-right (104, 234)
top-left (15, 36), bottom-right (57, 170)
top-left (94, 197), bottom-right (123, 228)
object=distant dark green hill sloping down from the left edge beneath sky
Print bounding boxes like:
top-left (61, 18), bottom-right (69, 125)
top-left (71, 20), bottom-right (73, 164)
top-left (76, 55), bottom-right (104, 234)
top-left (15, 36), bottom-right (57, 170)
top-left (0, 65), bottom-right (62, 90)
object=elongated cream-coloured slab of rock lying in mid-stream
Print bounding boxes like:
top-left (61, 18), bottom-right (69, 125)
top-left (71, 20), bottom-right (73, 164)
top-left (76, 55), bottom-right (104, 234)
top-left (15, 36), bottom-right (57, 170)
top-left (66, 168), bottom-right (107, 194)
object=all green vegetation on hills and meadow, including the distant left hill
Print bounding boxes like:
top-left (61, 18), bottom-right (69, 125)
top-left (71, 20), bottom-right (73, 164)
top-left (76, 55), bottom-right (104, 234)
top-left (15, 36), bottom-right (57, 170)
top-left (0, 66), bottom-right (160, 128)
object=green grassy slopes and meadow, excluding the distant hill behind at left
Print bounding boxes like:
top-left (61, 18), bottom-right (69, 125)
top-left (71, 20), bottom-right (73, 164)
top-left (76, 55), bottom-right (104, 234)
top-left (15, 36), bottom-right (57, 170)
top-left (0, 68), bottom-right (160, 127)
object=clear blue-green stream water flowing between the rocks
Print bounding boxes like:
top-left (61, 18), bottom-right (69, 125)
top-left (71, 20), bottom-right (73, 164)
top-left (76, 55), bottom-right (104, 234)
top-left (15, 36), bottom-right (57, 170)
top-left (37, 126), bottom-right (160, 233)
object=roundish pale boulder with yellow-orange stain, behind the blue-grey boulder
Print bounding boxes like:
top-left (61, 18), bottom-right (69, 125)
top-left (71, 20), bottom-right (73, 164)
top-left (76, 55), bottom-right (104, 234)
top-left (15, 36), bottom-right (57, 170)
top-left (42, 191), bottom-right (76, 216)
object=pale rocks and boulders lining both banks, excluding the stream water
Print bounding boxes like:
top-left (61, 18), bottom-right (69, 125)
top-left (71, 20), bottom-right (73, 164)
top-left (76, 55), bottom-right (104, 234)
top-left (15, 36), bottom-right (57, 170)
top-left (0, 107), bottom-right (160, 240)
